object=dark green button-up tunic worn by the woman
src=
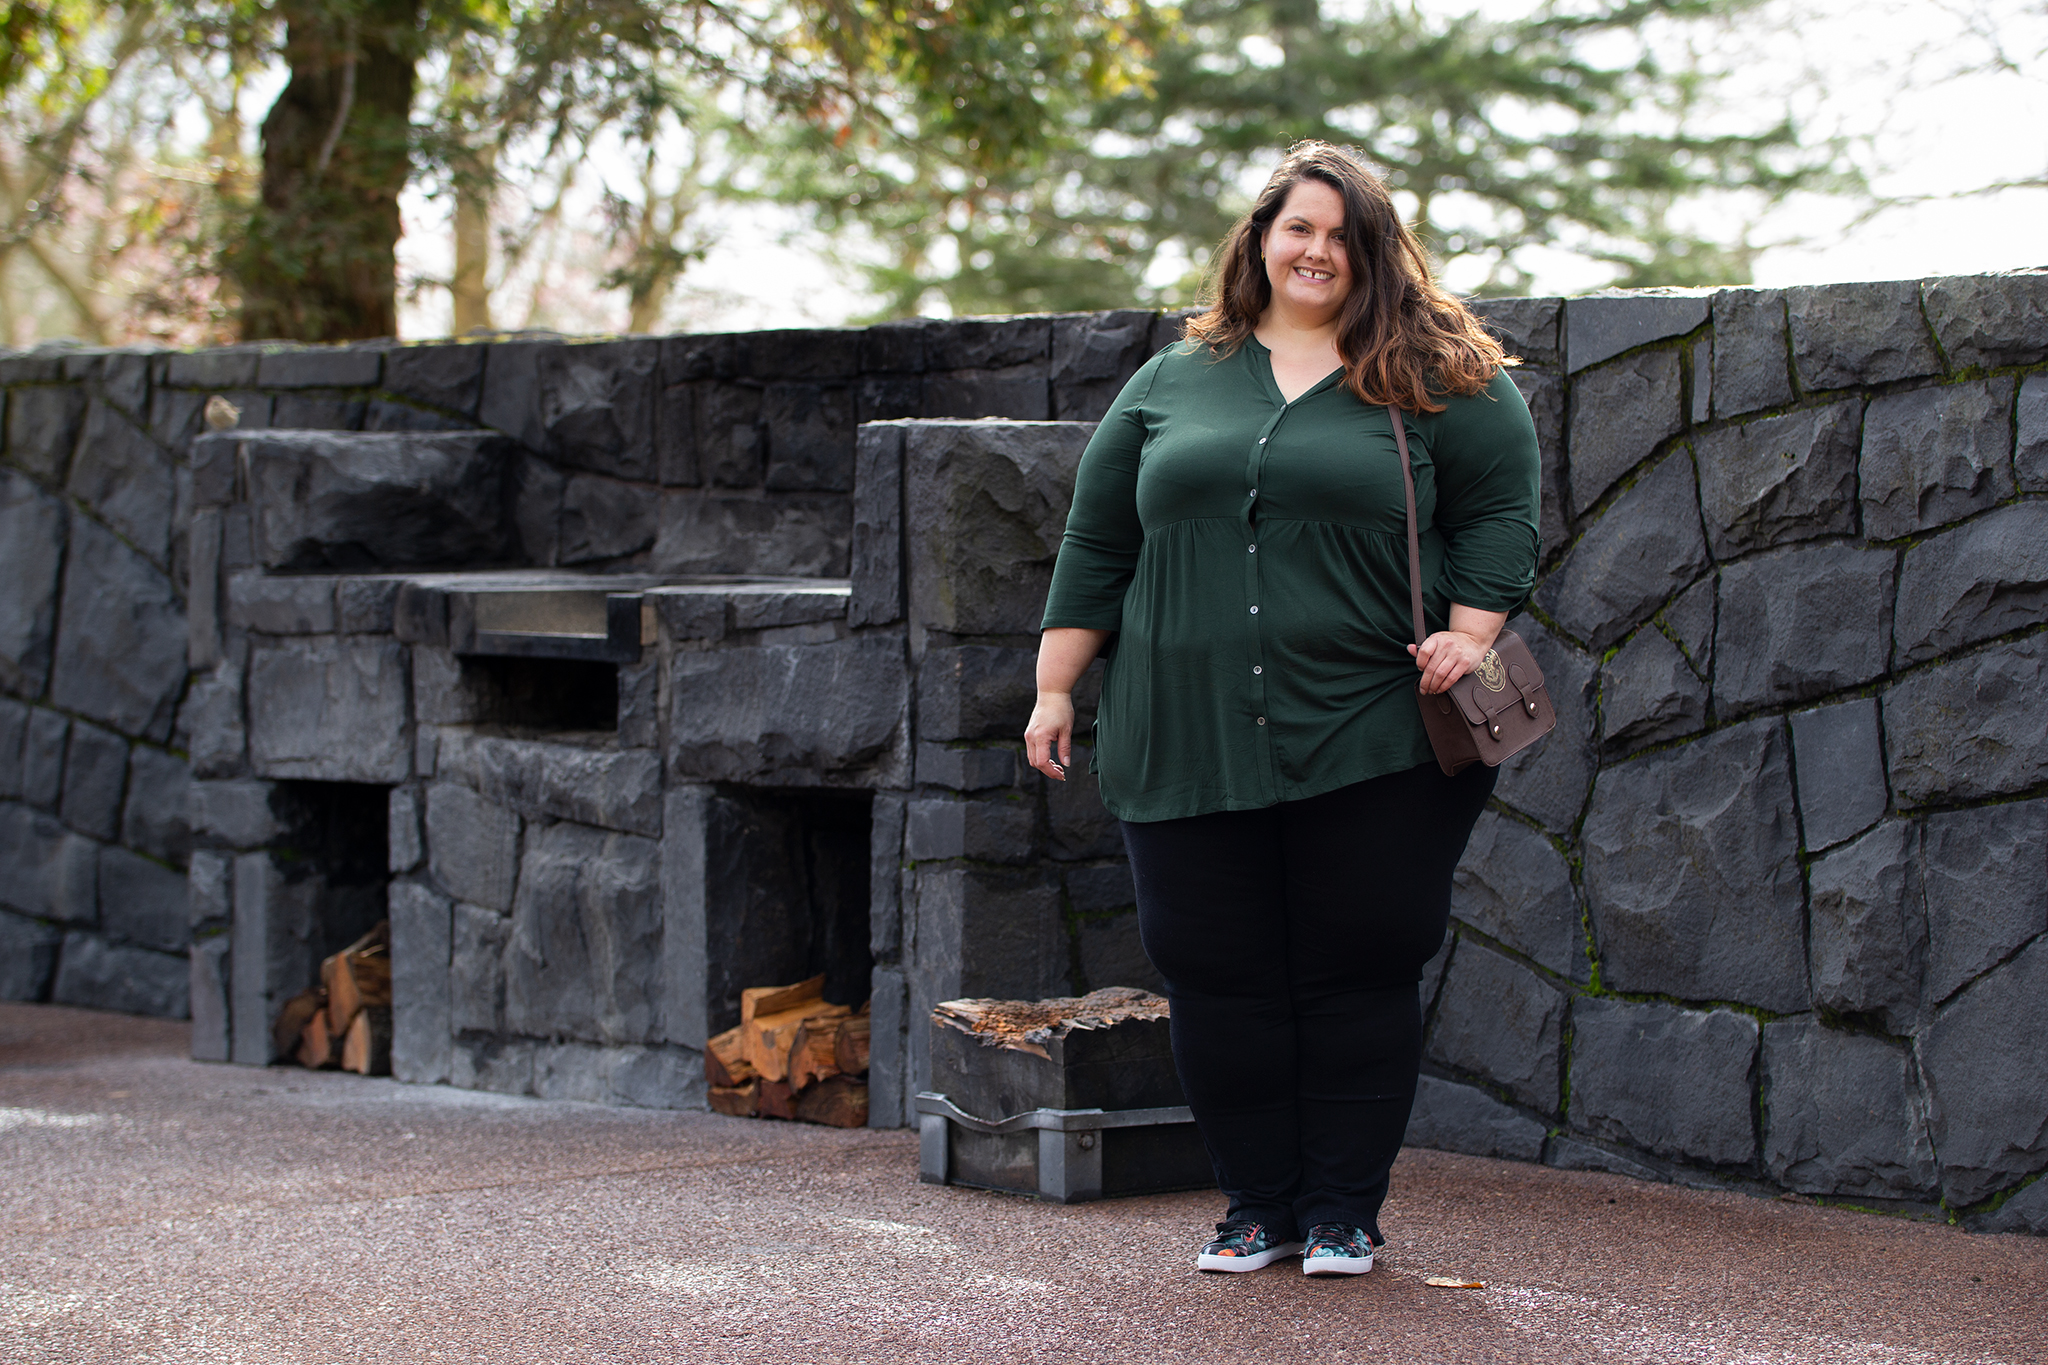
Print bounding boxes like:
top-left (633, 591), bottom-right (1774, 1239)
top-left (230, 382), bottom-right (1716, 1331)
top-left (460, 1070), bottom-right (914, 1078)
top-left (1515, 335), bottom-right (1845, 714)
top-left (1044, 340), bottom-right (1540, 821)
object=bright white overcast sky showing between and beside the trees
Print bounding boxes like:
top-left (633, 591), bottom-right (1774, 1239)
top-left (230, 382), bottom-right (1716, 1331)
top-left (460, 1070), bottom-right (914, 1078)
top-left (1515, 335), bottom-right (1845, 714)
top-left (401, 0), bottom-right (2048, 336)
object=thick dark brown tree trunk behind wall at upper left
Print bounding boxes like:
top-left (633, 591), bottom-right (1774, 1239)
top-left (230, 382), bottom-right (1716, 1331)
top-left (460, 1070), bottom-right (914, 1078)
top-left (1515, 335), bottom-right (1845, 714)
top-left (229, 0), bottom-right (418, 342)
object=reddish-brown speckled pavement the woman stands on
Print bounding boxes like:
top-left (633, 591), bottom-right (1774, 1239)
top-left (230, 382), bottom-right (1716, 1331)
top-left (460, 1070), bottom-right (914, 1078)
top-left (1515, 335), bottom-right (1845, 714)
top-left (0, 1005), bottom-right (2048, 1365)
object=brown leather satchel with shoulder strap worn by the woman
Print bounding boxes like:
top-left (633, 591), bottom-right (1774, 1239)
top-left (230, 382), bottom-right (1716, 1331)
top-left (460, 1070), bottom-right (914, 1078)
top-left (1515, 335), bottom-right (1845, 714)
top-left (1386, 405), bottom-right (1556, 774)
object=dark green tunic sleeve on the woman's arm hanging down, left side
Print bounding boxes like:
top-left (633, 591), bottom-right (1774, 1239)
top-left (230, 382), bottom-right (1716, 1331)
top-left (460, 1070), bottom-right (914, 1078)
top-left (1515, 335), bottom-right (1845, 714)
top-left (1038, 356), bottom-right (1159, 630)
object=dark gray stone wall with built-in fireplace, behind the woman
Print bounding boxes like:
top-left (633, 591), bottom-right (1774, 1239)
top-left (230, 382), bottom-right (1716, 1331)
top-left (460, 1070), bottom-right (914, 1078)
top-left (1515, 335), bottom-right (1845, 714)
top-left (0, 272), bottom-right (2048, 1232)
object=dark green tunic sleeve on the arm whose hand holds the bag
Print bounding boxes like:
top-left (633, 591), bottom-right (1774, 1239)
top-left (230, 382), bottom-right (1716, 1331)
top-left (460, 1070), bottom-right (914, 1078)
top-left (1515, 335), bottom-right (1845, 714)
top-left (1430, 370), bottom-right (1542, 612)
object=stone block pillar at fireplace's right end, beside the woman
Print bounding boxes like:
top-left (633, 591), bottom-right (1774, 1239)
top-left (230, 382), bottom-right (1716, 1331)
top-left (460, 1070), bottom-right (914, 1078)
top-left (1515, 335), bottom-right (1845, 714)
top-left (850, 422), bottom-right (1159, 1124)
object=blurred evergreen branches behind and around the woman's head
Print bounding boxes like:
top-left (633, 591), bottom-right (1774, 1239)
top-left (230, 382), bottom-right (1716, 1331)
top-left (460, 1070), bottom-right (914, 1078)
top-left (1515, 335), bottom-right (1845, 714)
top-left (778, 0), bottom-right (1851, 313)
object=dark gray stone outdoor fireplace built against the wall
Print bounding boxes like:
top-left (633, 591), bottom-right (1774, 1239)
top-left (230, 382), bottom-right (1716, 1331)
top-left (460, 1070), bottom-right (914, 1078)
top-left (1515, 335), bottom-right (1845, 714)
top-left (169, 315), bottom-right (1153, 1126)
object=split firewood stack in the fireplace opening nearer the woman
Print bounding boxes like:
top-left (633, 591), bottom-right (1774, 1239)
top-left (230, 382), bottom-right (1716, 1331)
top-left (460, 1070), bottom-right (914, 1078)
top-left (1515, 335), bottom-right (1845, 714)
top-left (705, 976), bottom-right (868, 1128)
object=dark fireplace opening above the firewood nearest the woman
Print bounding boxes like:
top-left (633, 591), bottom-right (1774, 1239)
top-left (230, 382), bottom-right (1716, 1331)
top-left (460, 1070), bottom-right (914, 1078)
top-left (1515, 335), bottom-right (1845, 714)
top-left (705, 786), bottom-right (874, 1033)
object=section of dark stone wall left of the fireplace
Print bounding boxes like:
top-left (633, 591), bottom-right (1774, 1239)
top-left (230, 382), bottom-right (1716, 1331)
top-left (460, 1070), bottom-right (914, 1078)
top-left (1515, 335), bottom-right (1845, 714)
top-left (0, 352), bottom-right (193, 1015)
